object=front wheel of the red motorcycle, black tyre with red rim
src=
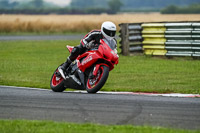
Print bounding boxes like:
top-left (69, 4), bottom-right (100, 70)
top-left (86, 65), bottom-right (109, 93)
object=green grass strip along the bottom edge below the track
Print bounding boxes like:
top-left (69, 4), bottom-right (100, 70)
top-left (0, 120), bottom-right (200, 133)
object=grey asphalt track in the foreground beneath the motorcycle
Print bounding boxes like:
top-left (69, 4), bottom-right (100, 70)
top-left (0, 86), bottom-right (200, 129)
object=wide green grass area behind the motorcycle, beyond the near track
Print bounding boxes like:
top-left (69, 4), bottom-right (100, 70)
top-left (0, 41), bottom-right (200, 94)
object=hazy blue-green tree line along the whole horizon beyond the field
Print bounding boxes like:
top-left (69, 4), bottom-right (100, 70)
top-left (0, 0), bottom-right (200, 14)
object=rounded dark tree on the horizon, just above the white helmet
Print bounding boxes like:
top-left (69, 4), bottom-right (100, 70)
top-left (108, 0), bottom-right (123, 13)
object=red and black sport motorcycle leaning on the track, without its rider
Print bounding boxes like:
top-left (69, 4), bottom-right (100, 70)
top-left (50, 39), bottom-right (119, 93)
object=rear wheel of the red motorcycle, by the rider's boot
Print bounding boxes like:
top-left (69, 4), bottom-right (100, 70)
top-left (50, 69), bottom-right (65, 92)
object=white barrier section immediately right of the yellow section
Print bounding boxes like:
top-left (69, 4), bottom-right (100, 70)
top-left (165, 23), bottom-right (193, 56)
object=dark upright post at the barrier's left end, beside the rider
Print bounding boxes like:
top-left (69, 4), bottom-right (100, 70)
top-left (120, 24), bottom-right (129, 56)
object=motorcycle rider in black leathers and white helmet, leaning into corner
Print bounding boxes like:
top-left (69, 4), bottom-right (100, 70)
top-left (58, 21), bottom-right (117, 79)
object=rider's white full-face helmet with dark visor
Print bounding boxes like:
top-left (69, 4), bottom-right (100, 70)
top-left (101, 21), bottom-right (117, 40)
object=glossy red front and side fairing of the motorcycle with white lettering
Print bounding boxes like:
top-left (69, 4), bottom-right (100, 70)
top-left (75, 40), bottom-right (119, 74)
